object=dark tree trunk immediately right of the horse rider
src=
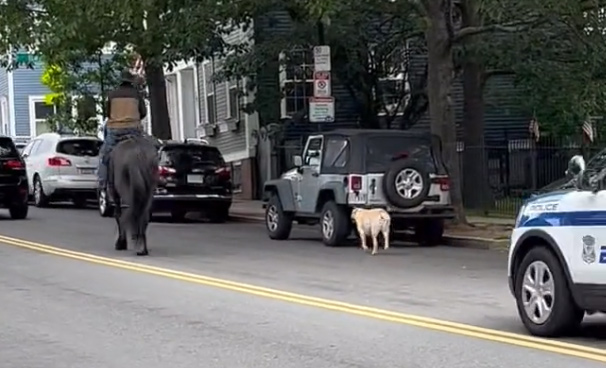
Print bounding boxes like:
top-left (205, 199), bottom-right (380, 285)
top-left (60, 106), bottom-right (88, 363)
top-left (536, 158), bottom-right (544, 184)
top-left (145, 64), bottom-right (172, 140)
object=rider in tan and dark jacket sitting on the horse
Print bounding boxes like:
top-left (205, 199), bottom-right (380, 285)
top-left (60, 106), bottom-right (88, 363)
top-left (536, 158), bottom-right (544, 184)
top-left (98, 70), bottom-right (147, 189)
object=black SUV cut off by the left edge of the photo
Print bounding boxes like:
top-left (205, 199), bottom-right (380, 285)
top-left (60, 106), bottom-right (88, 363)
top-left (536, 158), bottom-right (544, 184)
top-left (0, 136), bottom-right (28, 220)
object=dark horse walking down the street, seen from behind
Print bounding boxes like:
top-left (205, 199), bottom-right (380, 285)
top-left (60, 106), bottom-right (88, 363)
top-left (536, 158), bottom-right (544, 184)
top-left (107, 136), bottom-right (159, 256)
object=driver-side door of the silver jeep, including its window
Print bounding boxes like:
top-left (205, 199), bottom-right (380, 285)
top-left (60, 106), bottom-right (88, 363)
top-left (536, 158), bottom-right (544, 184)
top-left (297, 136), bottom-right (323, 214)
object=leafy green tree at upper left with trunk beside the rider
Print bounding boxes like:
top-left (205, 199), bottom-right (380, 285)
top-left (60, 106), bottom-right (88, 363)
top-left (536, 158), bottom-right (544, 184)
top-left (0, 0), bottom-right (228, 139)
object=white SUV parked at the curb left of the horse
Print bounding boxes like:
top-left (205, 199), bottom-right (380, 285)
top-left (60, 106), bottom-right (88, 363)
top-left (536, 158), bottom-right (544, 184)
top-left (22, 133), bottom-right (103, 207)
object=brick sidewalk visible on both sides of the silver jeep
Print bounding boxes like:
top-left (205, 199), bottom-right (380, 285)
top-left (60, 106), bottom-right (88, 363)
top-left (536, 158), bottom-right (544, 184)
top-left (230, 201), bottom-right (515, 250)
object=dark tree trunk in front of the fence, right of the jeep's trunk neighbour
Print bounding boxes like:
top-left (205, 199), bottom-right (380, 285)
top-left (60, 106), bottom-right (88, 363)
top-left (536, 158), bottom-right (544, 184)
top-left (461, 0), bottom-right (491, 210)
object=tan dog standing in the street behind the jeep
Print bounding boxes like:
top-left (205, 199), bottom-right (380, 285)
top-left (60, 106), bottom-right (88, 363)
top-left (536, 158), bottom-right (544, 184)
top-left (351, 208), bottom-right (391, 255)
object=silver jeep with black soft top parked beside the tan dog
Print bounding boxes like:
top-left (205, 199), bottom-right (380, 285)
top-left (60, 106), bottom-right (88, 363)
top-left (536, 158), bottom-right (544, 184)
top-left (263, 129), bottom-right (454, 246)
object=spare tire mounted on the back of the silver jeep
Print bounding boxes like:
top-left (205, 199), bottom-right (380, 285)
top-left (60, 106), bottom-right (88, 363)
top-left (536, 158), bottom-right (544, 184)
top-left (382, 159), bottom-right (431, 208)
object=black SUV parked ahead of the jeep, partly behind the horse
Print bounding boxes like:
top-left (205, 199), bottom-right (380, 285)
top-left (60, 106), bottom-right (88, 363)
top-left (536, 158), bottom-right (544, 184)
top-left (98, 140), bottom-right (232, 222)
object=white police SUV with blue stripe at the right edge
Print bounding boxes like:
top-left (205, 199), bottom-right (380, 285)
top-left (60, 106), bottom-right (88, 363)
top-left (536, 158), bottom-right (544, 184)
top-left (507, 156), bottom-right (606, 337)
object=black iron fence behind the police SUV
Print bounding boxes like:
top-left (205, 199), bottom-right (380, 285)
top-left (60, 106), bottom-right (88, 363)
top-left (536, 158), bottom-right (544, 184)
top-left (458, 140), bottom-right (604, 216)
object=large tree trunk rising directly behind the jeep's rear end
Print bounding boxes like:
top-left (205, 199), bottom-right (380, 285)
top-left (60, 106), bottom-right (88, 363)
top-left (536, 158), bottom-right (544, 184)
top-left (425, 0), bottom-right (467, 223)
